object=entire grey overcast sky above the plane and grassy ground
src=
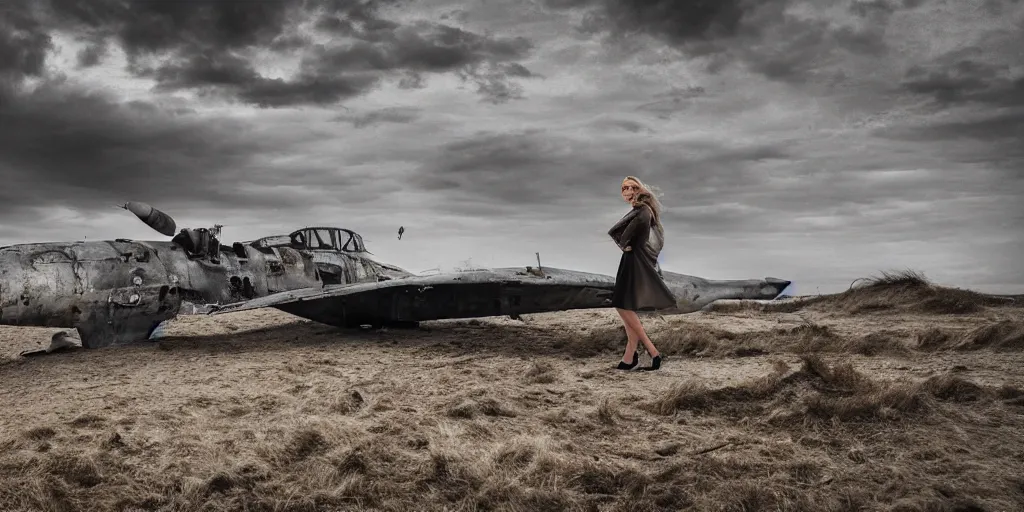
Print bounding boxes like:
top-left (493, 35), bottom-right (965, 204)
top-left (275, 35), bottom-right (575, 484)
top-left (0, 0), bottom-right (1024, 293)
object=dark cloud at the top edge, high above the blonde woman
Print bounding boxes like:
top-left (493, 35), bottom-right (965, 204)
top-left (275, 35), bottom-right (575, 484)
top-left (545, 0), bottom-right (913, 83)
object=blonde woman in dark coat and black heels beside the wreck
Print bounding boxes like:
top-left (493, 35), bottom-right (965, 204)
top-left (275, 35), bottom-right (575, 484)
top-left (608, 176), bottom-right (676, 370)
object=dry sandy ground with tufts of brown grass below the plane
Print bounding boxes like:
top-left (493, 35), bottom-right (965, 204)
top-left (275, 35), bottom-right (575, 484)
top-left (0, 292), bottom-right (1024, 511)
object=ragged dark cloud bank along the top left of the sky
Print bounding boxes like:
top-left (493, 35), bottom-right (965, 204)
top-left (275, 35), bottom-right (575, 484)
top-left (22, 0), bottom-right (531, 108)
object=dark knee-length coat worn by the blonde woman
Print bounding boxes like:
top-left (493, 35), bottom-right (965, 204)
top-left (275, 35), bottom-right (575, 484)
top-left (608, 205), bottom-right (676, 311)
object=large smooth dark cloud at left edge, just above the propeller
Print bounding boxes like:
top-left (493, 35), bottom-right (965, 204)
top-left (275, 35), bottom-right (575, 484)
top-left (0, 86), bottom-right (315, 212)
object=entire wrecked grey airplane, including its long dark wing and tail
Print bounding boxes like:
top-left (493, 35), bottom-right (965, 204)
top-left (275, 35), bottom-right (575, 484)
top-left (0, 202), bottom-right (790, 351)
